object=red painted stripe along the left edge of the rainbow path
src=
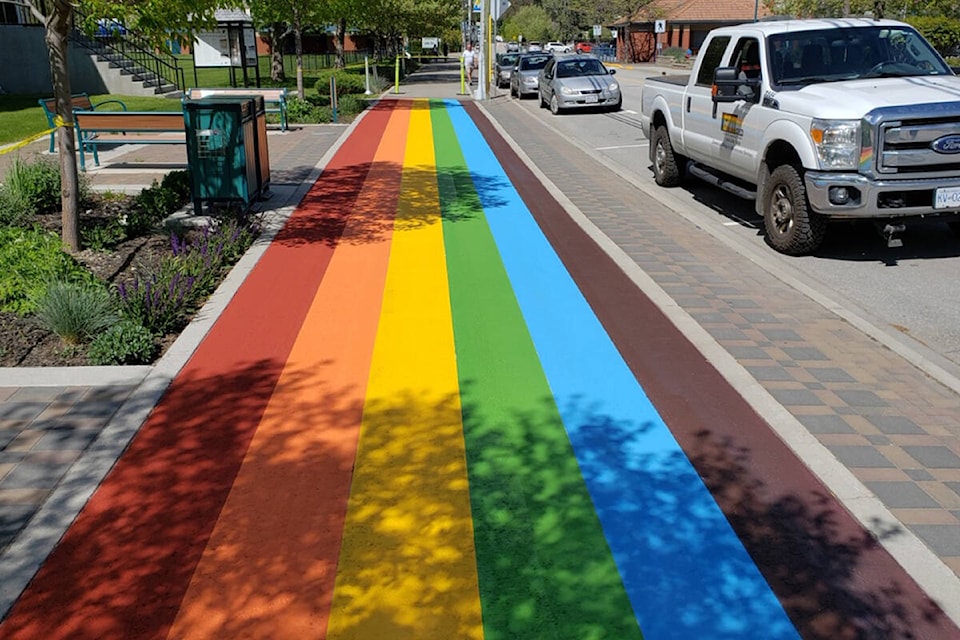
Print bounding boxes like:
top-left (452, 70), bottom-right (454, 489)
top-left (0, 104), bottom-right (392, 640)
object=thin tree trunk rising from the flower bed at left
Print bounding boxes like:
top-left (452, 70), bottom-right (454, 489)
top-left (44, 0), bottom-right (80, 252)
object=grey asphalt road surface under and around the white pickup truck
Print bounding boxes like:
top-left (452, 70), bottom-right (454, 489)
top-left (503, 67), bottom-right (960, 374)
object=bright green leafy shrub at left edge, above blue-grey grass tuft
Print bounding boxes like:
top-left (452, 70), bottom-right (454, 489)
top-left (0, 227), bottom-right (95, 315)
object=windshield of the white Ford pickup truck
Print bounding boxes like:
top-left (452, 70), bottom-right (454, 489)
top-left (767, 26), bottom-right (952, 86)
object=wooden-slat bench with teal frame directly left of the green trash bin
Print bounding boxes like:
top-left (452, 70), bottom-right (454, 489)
top-left (73, 111), bottom-right (187, 171)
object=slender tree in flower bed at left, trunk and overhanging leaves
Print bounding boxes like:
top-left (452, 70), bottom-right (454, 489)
top-left (19, 0), bottom-right (221, 251)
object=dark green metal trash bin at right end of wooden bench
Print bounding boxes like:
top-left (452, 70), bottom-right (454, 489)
top-left (183, 96), bottom-right (262, 215)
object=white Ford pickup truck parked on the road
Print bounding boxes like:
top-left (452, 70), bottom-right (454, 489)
top-left (642, 18), bottom-right (960, 255)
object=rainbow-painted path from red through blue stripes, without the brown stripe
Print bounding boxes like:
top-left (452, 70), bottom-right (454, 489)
top-left (0, 100), bottom-right (797, 640)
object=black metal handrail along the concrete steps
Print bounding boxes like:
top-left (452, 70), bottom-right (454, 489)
top-left (72, 9), bottom-right (187, 91)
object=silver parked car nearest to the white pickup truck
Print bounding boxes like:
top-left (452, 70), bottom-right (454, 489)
top-left (537, 54), bottom-right (623, 115)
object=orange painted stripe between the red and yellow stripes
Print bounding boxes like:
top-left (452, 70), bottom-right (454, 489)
top-left (170, 104), bottom-right (410, 638)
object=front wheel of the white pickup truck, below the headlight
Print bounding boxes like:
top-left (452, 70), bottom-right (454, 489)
top-left (763, 164), bottom-right (827, 256)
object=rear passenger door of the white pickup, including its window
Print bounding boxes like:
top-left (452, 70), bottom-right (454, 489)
top-left (681, 36), bottom-right (730, 164)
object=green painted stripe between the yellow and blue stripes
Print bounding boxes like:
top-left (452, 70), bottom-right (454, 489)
top-left (432, 103), bottom-right (641, 640)
